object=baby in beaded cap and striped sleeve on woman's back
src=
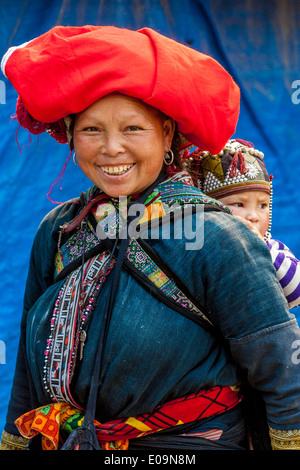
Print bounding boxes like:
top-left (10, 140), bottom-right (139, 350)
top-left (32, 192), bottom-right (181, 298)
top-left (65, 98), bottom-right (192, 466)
top-left (187, 139), bottom-right (300, 308)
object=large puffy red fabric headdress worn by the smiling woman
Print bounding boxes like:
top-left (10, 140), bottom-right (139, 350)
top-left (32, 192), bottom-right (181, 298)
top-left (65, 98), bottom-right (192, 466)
top-left (1, 26), bottom-right (240, 153)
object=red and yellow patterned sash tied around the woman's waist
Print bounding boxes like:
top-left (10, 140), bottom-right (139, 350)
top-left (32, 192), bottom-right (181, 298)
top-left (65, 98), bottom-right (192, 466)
top-left (15, 387), bottom-right (242, 450)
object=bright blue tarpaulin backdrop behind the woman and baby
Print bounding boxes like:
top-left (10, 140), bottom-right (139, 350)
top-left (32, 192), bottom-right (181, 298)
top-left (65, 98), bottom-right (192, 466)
top-left (0, 0), bottom-right (300, 432)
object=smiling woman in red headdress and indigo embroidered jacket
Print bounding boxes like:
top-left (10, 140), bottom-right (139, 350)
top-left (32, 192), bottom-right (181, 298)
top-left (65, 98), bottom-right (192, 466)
top-left (2, 26), bottom-right (300, 450)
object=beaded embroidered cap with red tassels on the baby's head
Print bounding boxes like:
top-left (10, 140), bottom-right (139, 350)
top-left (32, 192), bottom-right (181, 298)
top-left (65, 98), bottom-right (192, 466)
top-left (189, 139), bottom-right (271, 198)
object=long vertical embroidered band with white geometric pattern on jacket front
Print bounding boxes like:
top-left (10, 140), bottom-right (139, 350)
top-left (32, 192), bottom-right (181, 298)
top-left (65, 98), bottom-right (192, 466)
top-left (43, 252), bottom-right (115, 406)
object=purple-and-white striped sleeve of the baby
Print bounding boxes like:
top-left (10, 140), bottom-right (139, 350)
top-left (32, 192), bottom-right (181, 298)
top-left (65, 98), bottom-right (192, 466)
top-left (267, 238), bottom-right (300, 308)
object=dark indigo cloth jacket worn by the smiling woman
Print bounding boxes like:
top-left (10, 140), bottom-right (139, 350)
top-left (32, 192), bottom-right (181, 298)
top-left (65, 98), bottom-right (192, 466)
top-left (5, 183), bottom-right (300, 434)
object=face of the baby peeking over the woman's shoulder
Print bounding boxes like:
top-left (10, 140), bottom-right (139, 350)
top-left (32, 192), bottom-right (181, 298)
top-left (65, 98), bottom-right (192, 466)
top-left (219, 191), bottom-right (270, 236)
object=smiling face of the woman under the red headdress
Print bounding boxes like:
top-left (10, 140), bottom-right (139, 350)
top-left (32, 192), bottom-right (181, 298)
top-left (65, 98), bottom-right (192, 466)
top-left (73, 94), bottom-right (174, 197)
